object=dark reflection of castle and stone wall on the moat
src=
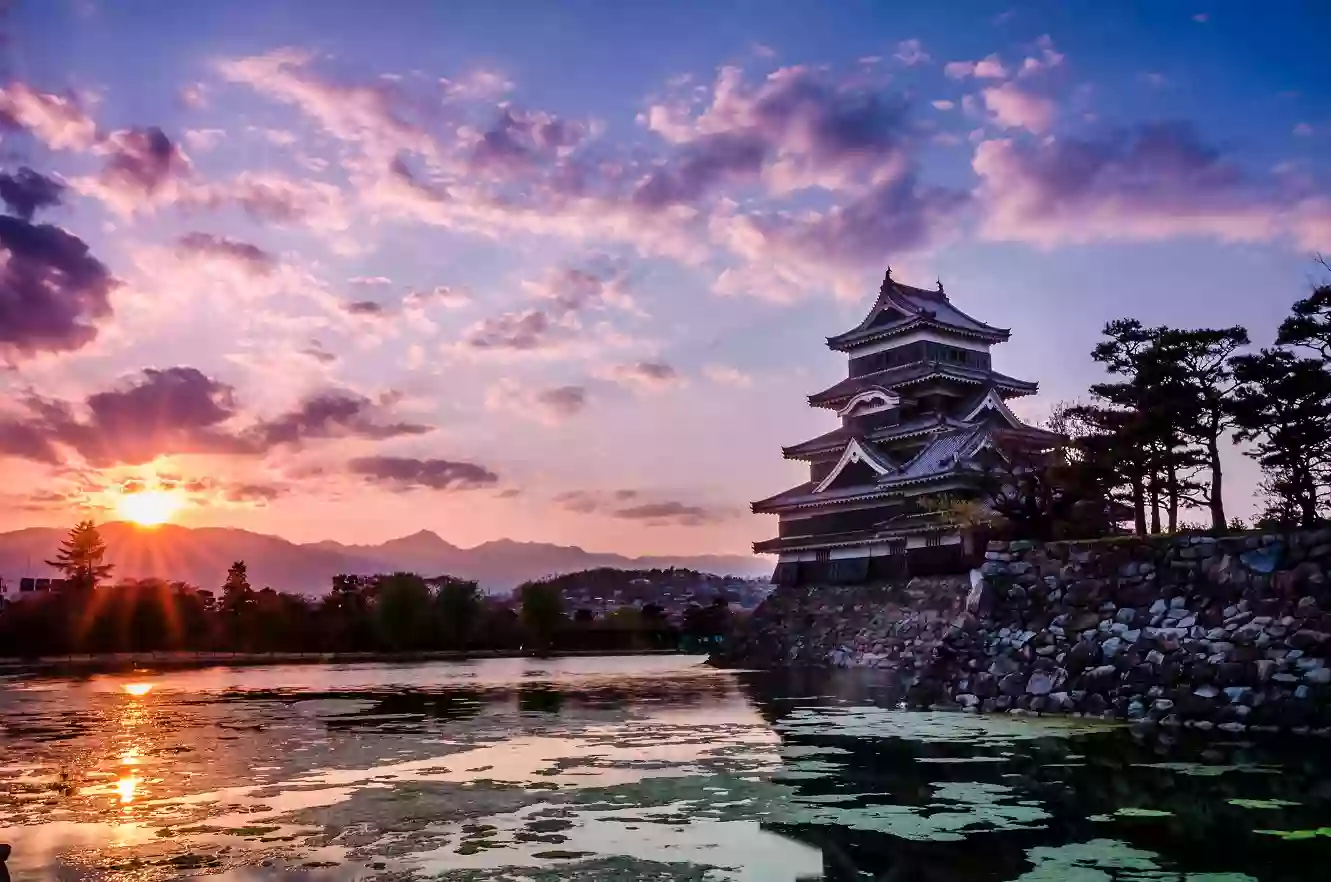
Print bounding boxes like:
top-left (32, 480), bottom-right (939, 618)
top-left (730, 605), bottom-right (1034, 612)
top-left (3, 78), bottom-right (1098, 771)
top-left (747, 674), bottom-right (1331, 882)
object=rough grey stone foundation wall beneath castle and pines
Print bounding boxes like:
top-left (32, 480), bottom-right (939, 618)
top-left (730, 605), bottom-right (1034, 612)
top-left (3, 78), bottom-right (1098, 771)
top-left (723, 529), bottom-right (1331, 732)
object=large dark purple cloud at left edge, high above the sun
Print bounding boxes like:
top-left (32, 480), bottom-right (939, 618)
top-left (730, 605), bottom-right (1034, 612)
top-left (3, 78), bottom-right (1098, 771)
top-left (0, 217), bottom-right (117, 358)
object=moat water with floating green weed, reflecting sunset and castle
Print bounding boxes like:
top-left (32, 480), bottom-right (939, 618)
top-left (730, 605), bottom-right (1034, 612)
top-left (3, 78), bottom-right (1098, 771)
top-left (0, 656), bottom-right (1331, 882)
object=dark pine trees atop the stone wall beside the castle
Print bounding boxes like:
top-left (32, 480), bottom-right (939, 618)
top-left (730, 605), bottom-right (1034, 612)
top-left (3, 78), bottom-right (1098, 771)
top-left (972, 263), bottom-right (1331, 539)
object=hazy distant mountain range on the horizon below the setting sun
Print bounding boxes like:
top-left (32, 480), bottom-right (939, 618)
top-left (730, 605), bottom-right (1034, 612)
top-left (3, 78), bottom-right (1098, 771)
top-left (0, 521), bottom-right (772, 593)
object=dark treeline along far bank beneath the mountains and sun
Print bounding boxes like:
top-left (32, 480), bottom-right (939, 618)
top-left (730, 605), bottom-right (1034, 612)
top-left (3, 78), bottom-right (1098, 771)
top-left (0, 521), bottom-right (728, 657)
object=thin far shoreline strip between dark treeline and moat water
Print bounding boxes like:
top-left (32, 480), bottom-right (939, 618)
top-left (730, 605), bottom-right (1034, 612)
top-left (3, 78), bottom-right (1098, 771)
top-left (0, 649), bottom-right (699, 676)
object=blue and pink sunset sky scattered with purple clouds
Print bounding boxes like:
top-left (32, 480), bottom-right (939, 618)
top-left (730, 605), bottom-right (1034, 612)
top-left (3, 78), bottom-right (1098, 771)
top-left (0, 0), bottom-right (1331, 553)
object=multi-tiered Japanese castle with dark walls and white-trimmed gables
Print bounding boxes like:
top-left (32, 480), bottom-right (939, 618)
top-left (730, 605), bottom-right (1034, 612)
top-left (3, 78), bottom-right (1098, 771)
top-left (752, 270), bottom-right (1058, 584)
